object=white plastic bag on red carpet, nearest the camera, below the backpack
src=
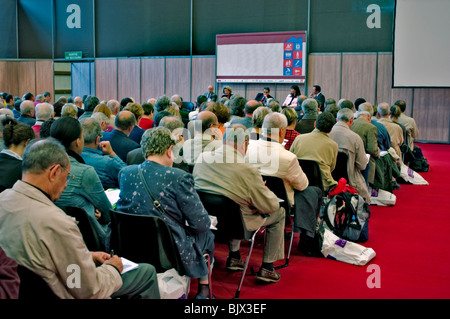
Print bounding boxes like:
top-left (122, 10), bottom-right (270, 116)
top-left (322, 228), bottom-right (376, 266)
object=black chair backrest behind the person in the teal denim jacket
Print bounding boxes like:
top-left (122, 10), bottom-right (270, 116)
top-left (61, 206), bottom-right (105, 251)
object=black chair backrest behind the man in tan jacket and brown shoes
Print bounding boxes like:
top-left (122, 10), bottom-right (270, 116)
top-left (197, 191), bottom-right (253, 243)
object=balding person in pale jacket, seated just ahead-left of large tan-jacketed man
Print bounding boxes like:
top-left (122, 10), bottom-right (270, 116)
top-left (183, 111), bottom-right (222, 165)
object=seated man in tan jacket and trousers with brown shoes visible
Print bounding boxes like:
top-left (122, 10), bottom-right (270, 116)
top-left (193, 124), bottom-right (285, 282)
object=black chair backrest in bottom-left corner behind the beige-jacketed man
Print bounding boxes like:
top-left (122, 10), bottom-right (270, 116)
top-left (17, 265), bottom-right (59, 300)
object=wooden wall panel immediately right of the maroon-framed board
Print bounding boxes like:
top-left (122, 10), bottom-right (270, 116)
top-left (310, 54), bottom-right (341, 102)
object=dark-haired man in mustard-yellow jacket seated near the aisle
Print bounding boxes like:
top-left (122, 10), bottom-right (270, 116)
top-left (290, 112), bottom-right (338, 191)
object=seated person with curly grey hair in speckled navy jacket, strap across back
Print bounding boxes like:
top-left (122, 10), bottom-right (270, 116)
top-left (117, 127), bottom-right (214, 299)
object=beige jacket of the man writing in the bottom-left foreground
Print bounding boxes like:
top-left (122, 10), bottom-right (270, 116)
top-left (0, 180), bottom-right (122, 299)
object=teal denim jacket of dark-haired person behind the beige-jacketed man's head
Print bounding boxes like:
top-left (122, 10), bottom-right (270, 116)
top-left (55, 154), bottom-right (112, 248)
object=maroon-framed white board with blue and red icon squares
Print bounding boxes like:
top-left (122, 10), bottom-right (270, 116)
top-left (216, 31), bottom-right (306, 83)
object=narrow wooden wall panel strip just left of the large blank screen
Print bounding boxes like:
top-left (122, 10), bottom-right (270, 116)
top-left (372, 54), bottom-right (392, 105)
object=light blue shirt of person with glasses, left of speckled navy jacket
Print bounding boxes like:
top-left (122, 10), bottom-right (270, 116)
top-left (81, 147), bottom-right (127, 189)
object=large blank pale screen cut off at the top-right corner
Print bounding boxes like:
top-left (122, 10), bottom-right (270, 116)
top-left (392, 0), bottom-right (450, 87)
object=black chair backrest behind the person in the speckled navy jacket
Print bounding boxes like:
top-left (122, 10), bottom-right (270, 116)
top-left (110, 210), bottom-right (186, 275)
